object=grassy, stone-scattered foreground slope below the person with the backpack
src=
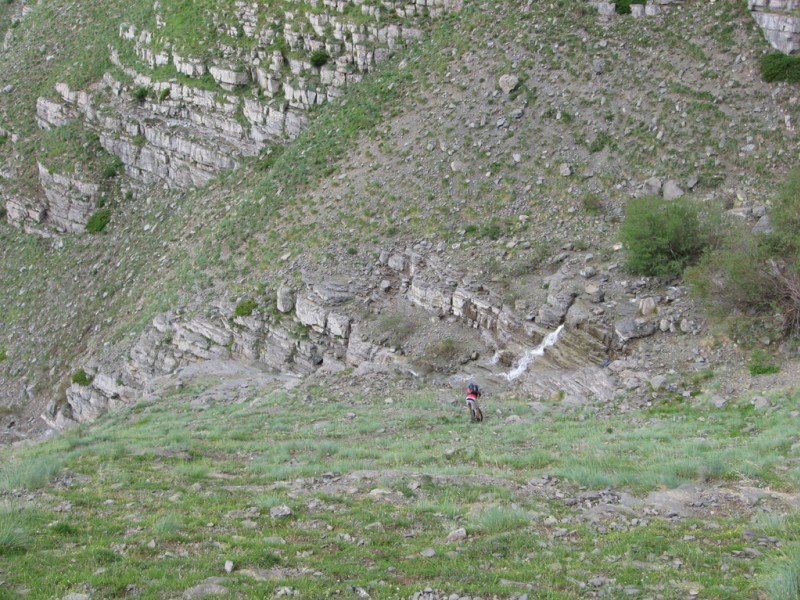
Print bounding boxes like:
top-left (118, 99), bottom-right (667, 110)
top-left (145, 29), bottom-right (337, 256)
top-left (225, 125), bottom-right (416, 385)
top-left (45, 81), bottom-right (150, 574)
top-left (0, 379), bottom-right (800, 599)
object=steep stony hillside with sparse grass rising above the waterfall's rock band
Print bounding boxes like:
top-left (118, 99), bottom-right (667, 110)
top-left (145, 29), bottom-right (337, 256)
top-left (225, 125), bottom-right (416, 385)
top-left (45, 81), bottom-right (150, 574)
top-left (0, 2), bottom-right (797, 434)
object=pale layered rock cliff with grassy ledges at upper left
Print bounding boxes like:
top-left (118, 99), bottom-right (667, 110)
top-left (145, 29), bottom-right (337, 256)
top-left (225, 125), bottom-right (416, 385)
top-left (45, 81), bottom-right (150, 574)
top-left (5, 0), bottom-right (461, 232)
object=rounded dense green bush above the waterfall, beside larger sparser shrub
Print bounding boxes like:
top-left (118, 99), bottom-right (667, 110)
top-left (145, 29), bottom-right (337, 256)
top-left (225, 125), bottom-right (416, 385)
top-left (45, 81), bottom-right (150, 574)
top-left (620, 196), bottom-right (711, 277)
